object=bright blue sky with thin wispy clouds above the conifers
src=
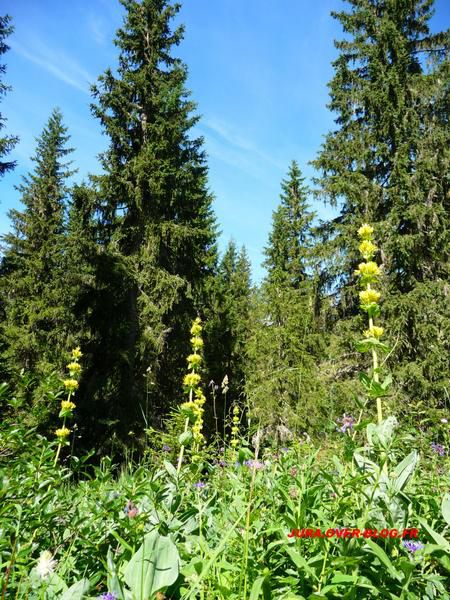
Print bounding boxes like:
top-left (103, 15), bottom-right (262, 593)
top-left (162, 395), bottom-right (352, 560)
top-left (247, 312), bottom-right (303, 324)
top-left (0, 0), bottom-right (450, 281)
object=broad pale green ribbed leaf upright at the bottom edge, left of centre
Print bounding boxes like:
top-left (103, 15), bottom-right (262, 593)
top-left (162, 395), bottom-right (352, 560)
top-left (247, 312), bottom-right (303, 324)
top-left (125, 530), bottom-right (180, 600)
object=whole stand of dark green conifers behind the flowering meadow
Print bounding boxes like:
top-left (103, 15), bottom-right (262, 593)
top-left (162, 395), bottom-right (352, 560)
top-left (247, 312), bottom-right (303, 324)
top-left (0, 0), bottom-right (450, 451)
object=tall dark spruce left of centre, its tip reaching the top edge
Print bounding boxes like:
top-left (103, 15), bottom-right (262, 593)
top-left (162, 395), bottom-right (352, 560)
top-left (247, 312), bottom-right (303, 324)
top-left (89, 0), bottom-right (215, 434)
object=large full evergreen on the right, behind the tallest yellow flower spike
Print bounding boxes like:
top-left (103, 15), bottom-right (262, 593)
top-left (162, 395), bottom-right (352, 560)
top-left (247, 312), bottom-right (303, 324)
top-left (313, 0), bottom-right (449, 412)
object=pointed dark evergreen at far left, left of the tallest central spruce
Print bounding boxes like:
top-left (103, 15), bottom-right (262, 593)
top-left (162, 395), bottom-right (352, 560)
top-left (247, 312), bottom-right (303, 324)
top-left (1, 109), bottom-right (73, 400)
